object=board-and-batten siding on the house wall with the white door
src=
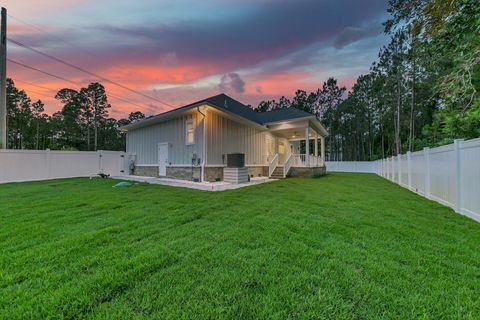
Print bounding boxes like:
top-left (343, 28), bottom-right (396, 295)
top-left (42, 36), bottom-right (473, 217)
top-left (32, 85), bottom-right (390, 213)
top-left (127, 111), bottom-right (203, 166)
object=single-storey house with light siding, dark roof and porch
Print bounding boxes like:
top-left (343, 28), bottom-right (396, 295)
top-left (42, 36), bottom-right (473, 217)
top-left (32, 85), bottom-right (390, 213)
top-left (122, 94), bottom-right (328, 181)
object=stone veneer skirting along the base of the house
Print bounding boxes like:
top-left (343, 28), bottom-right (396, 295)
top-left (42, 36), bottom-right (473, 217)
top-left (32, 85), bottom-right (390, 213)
top-left (133, 166), bottom-right (268, 182)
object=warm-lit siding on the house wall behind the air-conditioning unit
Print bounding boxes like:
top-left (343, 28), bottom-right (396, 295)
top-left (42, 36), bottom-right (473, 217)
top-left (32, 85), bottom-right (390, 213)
top-left (206, 111), bottom-right (275, 166)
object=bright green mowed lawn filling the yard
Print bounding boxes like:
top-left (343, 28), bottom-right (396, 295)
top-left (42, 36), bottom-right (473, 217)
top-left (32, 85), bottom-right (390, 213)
top-left (0, 174), bottom-right (480, 319)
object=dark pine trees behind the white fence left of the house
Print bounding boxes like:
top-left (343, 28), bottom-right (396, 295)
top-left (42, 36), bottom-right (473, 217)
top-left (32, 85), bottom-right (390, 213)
top-left (7, 79), bottom-right (145, 151)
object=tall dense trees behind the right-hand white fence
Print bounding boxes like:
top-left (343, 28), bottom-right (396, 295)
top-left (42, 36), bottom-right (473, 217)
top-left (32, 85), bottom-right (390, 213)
top-left (256, 0), bottom-right (480, 160)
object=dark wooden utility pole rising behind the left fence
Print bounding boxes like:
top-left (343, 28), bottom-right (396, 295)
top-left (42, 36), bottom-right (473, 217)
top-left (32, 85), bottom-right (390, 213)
top-left (0, 7), bottom-right (7, 149)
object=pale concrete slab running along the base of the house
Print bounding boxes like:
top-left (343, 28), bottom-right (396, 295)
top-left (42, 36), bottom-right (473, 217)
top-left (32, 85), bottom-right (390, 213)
top-left (112, 175), bottom-right (275, 191)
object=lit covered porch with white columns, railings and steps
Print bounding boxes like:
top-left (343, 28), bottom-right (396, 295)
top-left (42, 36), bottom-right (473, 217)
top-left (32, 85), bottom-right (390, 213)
top-left (268, 117), bottom-right (327, 178)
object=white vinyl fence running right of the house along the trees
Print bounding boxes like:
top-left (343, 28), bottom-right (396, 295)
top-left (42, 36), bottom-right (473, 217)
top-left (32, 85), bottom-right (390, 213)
top-left (326, 138), bottom-right (480, 222)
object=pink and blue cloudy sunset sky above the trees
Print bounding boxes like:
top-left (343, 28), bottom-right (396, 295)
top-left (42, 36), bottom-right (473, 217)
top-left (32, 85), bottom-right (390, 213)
top-left (0, 0), bottom-right (387, 118)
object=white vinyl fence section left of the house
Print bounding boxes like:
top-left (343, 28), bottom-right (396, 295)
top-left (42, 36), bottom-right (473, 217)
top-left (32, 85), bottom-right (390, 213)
top-left (0, 150), bottom-right (127, 183)
